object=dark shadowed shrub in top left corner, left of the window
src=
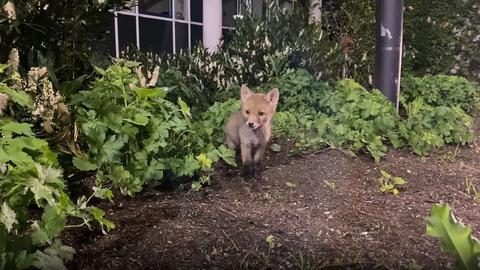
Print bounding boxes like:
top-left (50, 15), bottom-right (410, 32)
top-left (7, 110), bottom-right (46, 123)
top-left (0, 0), bottom-right (130, 83)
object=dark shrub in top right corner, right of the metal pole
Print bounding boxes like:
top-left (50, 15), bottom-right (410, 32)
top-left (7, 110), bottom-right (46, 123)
top-left (404, 0), bottom-right (480, 81)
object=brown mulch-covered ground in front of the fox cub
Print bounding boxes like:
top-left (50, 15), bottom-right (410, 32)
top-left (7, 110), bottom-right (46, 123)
top-left (64, 118), bottom-right (480, 270)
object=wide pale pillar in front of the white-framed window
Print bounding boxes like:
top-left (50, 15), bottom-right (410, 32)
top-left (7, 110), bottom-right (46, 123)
top-left (203, 0), bottom-right (222, 53)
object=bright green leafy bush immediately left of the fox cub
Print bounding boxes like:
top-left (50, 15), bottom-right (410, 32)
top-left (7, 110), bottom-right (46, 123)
top-left (72, 61), bottom-right (234, 195)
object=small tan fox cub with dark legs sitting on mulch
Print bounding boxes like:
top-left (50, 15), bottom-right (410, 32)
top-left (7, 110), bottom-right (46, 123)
top-left (225, 85), bottom-right (280, 173)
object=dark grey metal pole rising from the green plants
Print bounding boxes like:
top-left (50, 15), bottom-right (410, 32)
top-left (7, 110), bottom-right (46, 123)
top-left (375, 0), bottom-right (403, 111)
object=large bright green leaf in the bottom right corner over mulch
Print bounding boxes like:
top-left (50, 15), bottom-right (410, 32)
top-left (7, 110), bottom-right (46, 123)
top-left (427, 205), bottom-right (480, 270)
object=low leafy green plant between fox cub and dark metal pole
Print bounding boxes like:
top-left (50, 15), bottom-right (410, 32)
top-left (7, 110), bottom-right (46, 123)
top-left (273, 71), bottom-right (403, 161)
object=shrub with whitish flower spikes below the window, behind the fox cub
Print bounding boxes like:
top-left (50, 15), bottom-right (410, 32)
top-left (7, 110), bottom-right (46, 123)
top-left (123, 1), bottom-right (339, 111)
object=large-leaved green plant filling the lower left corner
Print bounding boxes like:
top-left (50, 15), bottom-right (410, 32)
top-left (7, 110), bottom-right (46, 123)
top-left (0, 80), bottom-right (110, 269)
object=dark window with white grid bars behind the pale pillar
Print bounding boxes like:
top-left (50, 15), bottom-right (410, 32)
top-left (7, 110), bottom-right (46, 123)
top-left (109, 0), bottom-right (274, 57)
